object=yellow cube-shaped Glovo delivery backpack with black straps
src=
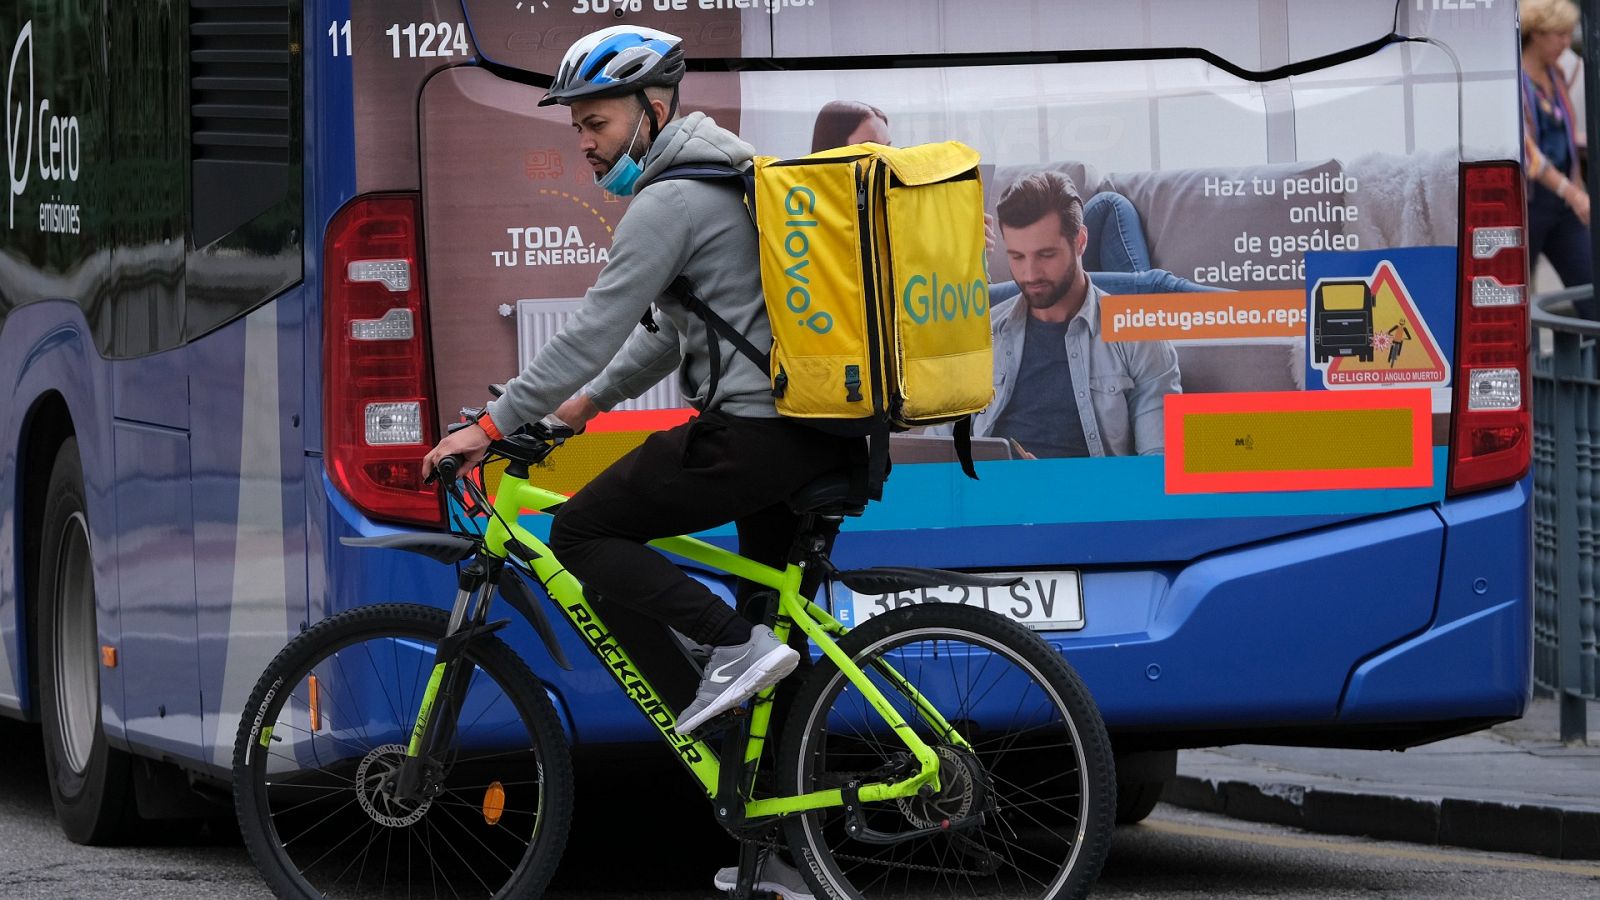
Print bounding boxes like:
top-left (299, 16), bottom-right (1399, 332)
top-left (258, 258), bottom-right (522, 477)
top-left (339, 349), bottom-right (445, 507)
top-left (658, 141), bottom-right (994, 496)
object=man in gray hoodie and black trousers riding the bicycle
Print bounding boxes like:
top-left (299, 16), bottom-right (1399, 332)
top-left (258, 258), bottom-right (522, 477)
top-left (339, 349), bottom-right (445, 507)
top-left (422, 26), bottom-right (861, 897)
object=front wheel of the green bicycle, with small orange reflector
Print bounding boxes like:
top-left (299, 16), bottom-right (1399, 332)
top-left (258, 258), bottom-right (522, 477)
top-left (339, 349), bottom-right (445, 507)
top-left (234, 605), bottom-right (573, 900)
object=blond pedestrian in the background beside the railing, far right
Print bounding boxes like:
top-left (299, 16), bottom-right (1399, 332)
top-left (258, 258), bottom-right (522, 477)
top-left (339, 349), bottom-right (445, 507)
top-left (1522, 0), bottom-right (1597, 312)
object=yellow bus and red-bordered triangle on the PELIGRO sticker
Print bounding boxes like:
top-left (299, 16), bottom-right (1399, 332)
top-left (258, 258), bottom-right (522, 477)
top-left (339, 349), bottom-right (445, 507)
top-left (1310, 259), bottom-right (1450, 388)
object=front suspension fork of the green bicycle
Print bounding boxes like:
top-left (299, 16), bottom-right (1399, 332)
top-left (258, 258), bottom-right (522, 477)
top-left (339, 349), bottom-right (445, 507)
top-left (394, 554), bottom-right (506, 802)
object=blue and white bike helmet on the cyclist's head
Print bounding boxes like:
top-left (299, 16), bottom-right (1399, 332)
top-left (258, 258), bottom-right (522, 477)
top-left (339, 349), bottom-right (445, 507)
top-left (539, 26), bottom-right (683, 106)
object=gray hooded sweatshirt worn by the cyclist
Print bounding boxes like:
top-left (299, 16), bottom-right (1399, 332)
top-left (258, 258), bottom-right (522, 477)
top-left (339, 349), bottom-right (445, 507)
top-left (490, 112), bottom-right (778, 434)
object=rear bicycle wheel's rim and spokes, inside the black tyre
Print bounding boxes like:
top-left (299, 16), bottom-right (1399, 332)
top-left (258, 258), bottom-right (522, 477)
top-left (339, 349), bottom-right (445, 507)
top-left (792, 626), bottom-right (1098, 898)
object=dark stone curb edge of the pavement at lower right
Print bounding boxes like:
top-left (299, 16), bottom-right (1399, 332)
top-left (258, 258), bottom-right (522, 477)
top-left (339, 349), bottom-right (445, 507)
top-left (1162, 773), bottom-right (1600, 860)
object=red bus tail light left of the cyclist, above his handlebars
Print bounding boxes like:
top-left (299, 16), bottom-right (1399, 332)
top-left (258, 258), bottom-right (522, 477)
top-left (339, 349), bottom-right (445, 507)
top-left (322, 194), bottom-right (443, 525)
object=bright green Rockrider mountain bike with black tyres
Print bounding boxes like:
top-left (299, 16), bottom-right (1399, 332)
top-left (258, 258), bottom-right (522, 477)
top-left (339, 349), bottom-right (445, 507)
top-left (234, 413), bottom-right (1115, 898)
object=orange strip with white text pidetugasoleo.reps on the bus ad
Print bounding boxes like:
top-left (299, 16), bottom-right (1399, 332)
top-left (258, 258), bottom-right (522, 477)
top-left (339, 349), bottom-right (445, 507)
top-left (1101, 290), bottom-right (1306, 341)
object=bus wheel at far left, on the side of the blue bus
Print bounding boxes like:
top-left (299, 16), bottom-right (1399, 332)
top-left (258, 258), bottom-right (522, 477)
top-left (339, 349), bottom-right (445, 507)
top-left (34, 437), bottom-right (133, 844)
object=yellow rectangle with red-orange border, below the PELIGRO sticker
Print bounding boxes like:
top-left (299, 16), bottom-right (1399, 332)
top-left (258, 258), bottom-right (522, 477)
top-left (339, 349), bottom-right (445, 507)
top-left (1165, 388), bottom-right (1434, 493)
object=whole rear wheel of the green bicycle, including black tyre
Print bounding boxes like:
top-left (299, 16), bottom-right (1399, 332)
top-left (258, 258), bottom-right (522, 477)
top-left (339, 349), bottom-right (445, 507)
top-left (778, 604), bottom-right (1117, 900)
